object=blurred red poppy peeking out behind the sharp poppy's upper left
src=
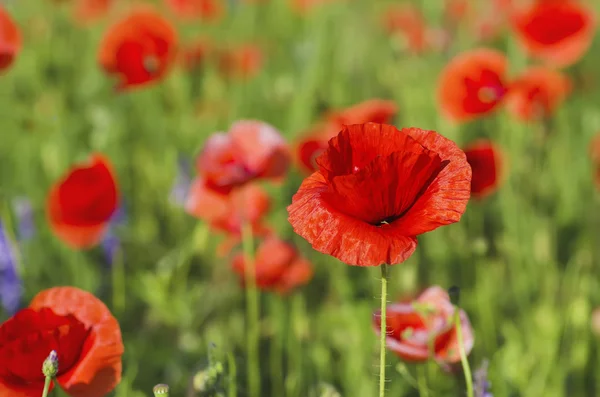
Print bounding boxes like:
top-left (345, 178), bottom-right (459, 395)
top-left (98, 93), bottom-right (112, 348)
top-left (296, 99), bottom-right (398, 173)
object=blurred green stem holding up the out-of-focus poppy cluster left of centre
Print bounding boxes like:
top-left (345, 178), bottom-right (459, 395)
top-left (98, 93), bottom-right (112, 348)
top-left (242, 222), bottom-right (260, 397)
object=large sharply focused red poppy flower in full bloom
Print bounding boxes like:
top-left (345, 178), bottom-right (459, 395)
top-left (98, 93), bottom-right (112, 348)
top-left (288, 123), bottom-right (471, 266)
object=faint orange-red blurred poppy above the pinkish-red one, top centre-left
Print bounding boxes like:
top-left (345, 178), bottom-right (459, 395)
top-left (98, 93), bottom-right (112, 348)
top-left (217, 44), bottom-right (263, 79)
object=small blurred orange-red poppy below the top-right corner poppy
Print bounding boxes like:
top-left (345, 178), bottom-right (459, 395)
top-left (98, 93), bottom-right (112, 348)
top-left (506, 67), bottom-right (571, 121)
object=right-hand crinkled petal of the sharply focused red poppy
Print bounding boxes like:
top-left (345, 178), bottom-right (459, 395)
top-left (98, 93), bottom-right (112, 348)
top-left (393, 128), bottom-right (471, 236)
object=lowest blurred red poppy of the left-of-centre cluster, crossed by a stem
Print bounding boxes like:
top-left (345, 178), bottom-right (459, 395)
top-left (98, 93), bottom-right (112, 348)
top-left (233, 236), bottom-right (313, 294)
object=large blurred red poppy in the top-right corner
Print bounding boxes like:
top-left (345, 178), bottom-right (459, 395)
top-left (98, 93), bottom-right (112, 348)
top-left (513, 0), bottom-right (595, 67)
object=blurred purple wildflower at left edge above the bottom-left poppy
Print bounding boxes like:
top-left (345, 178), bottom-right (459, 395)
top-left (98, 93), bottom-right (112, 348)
top-left (0, 221), bottom-right (23, 315)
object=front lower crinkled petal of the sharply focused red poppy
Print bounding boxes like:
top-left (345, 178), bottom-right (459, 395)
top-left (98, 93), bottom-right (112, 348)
top-left (288, 172), bottom-right (417, 266)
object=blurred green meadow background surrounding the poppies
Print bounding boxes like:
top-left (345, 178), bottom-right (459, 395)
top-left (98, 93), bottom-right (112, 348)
top-left (0, 0), bottom-right (600, 397)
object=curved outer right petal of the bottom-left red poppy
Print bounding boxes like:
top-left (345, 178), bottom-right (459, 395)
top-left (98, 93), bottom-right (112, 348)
top-left (29, 287), bottom-right (124, 397)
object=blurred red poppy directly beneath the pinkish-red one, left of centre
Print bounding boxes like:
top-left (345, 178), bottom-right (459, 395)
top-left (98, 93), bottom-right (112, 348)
top-left (185, 178), bottom-right (270, 255)
